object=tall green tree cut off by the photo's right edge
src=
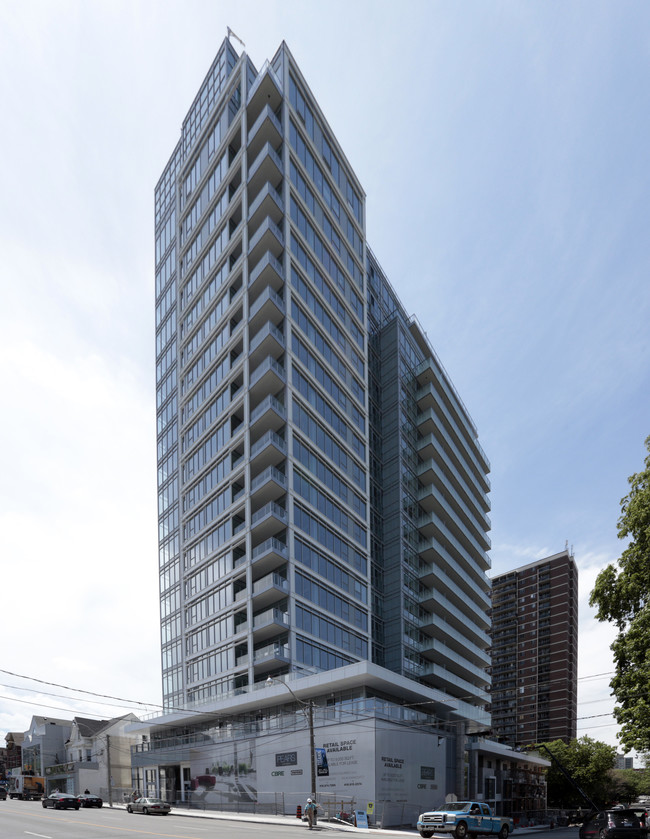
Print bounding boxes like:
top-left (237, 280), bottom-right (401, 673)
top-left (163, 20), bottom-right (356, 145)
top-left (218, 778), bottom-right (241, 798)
top-left (589, 437), bottom-right (650, 752)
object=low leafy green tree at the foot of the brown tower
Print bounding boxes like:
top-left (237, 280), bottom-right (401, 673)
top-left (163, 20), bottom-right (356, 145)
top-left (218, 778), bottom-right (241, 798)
top-left (537, 736), bottom-right (616, 809)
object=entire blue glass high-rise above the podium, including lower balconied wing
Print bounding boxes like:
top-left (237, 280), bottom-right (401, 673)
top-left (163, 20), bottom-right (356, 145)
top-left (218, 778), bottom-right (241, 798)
top-left (156, 40), bottom-right (489, 720)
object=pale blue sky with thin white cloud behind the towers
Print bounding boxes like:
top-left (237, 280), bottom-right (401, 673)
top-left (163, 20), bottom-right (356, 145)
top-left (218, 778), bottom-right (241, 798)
top-left (0, 0), bottom-right (650, 756)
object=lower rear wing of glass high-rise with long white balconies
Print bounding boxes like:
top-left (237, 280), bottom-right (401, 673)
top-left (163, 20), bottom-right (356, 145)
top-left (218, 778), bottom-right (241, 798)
top-left (367, 256), bottom-right (490, 716)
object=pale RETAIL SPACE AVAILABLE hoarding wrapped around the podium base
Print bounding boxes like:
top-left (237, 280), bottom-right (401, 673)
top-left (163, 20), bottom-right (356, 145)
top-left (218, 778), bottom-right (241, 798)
top-left (182, 719), bottom-right (445, 812)
